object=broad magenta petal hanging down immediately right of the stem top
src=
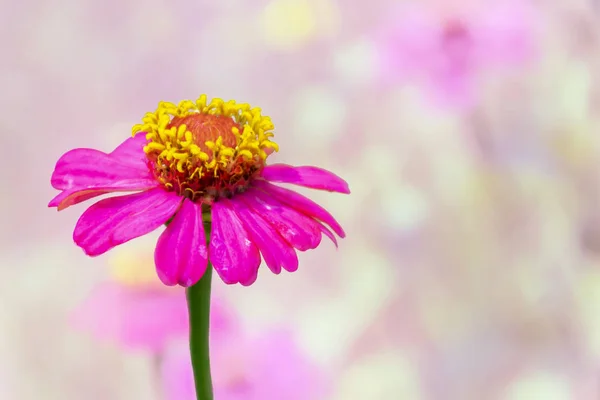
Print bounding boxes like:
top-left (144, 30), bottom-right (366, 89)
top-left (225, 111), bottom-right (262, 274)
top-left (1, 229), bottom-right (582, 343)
top-left (209, 199), bottom-right (260, 286)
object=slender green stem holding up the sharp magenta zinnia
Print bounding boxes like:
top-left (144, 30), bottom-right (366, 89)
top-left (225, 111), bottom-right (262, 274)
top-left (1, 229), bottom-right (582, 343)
top-left (186, 263), bottom-right (213, 400)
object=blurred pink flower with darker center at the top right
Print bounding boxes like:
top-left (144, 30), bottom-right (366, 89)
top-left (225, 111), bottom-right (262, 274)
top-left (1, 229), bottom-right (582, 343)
top-left (378, 1), bottom-right (535, 108)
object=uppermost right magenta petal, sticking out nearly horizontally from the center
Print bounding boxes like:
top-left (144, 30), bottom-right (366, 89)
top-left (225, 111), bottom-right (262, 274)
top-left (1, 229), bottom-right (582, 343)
top-left (261, 164), bottom-right (350, 194)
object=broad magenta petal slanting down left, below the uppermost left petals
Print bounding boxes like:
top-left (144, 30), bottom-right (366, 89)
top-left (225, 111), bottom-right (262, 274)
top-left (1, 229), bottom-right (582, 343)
top-left (73, 188), bottom-right (181, 256)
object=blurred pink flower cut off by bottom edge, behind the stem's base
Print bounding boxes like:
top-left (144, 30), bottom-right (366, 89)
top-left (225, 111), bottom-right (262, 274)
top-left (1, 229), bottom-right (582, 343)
top-left (162, 331), bottom-right (327, 400)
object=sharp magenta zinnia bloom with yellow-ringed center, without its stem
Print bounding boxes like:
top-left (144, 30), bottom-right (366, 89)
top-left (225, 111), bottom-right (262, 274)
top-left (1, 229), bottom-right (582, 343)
top-left (49, 95), bottom-right (350, 286)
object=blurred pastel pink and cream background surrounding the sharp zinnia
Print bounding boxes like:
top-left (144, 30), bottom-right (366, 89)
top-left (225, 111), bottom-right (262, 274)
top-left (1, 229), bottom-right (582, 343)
top-left (0, 0), bottom-right (600, 400)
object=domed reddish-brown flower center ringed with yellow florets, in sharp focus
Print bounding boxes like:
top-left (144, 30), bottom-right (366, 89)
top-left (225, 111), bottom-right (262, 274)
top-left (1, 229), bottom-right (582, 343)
top-left (133, 95), bottom-right (278, 204)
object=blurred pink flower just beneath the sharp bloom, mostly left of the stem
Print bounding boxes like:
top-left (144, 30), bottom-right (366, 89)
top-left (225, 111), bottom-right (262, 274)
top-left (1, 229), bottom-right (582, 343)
top-left (71, 282), bottom-right (236, 354)
